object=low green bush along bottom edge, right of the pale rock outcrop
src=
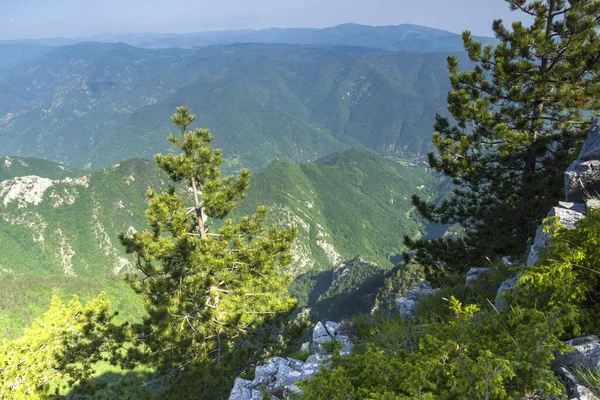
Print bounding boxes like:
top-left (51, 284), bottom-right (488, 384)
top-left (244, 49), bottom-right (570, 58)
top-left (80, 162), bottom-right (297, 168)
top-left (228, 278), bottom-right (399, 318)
top-left (303, 297), bottom-right (562, 399)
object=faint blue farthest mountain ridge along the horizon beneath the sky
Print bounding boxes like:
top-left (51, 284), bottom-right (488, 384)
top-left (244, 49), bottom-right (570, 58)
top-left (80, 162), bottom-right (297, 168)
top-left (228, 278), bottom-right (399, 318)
top-left (0, 23), bottom-right (494, 52)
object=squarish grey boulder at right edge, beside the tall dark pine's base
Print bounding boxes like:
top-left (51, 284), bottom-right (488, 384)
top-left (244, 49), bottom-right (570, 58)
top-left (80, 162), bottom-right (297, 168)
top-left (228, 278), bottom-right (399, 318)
top-left (565, 160), bottom-right (600, 202)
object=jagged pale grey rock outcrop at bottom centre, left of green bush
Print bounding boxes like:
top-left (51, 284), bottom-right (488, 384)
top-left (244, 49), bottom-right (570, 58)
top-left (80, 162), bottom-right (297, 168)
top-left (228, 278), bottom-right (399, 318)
top-left (229, 321), bottom-right (352, 400)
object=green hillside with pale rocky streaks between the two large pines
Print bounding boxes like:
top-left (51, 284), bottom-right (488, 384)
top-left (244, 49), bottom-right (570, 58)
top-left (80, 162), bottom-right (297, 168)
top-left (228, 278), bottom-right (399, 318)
top-left (237, 149), bottom-right (438, 272)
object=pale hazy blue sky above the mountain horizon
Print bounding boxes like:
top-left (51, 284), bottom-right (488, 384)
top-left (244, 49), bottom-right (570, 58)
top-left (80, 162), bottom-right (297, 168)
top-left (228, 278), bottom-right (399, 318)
top-left (0, 0), bottom-right (522, 40)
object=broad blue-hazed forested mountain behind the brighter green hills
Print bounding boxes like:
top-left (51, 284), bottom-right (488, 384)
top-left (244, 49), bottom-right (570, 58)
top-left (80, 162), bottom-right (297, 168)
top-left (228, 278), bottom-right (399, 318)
top-left (0, 43), bottom-right (449, 169)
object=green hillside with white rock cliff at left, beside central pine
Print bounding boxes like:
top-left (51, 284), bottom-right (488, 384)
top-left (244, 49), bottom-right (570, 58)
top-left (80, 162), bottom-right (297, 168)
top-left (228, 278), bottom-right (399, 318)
top-left (0, 159), bottom-right (164, 277)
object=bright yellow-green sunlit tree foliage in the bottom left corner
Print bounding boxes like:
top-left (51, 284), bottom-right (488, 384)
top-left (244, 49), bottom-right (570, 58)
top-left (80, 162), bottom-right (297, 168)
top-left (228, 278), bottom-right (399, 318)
top-left (0, 293), bottom-right (113, 399)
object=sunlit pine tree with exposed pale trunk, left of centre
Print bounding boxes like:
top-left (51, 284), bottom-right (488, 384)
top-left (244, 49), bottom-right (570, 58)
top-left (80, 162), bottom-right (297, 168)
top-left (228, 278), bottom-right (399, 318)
top-left (120, 107), bottom-right (297, 380)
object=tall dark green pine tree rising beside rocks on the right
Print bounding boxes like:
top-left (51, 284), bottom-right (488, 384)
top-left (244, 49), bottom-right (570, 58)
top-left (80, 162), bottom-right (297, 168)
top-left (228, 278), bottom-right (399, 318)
top-left (405, 0), bottom-right (600, 279)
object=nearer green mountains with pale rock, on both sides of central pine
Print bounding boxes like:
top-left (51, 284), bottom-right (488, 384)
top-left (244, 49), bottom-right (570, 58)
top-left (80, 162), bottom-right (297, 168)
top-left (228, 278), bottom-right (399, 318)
top-left (0, 149), bottom-right (441, 335)
